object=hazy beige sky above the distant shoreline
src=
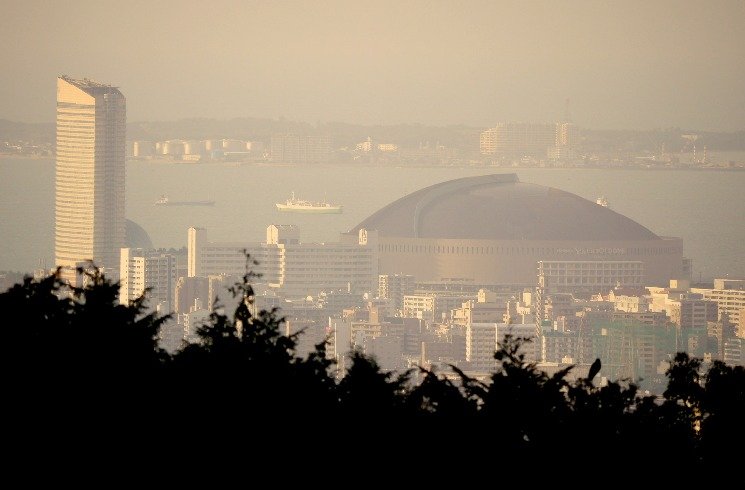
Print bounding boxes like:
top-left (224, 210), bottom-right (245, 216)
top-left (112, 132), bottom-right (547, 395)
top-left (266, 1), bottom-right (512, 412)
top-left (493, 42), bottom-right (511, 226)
top-left (0, 0), bottom-right (745, 131)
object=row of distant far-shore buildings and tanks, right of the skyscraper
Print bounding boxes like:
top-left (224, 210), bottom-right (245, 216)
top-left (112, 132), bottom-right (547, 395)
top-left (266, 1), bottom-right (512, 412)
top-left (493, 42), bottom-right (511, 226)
top-left (123, 122), bottom-right (745, 169)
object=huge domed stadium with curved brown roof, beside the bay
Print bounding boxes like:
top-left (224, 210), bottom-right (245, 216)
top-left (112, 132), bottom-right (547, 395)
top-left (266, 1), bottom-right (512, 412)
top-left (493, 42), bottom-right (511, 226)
top-left (349, 174), bottom-right (683, 289)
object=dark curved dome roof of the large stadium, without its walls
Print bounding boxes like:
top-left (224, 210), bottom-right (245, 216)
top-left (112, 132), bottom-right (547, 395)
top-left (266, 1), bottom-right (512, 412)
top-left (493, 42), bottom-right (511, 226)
top-left (350, 174), bottom-right (660, 241)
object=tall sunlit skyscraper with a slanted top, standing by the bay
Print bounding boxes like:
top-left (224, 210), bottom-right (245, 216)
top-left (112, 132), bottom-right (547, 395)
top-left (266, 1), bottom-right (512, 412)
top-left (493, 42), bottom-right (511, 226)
top-left (54, 75), bottom-right (127, 284)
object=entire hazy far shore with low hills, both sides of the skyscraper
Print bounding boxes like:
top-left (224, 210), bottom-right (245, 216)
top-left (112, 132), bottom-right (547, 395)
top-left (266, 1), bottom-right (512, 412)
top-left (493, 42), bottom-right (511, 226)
top-left (0, 117), bottom-right (745, 170)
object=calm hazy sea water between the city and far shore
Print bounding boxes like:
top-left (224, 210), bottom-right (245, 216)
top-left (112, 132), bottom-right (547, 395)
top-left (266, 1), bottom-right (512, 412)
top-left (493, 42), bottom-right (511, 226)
top-left (0, 158), bottom-right (745, 280)
